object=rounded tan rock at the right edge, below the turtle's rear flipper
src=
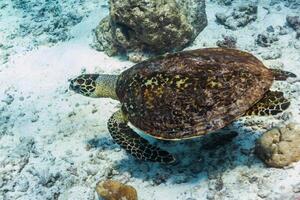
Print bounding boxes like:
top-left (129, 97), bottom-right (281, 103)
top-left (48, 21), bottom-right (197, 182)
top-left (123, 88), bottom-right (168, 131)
top-left (256, 124), bottom-right (300, 167)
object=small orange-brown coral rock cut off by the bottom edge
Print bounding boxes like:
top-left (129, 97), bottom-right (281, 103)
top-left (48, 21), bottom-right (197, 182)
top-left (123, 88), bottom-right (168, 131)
top-left (96, 180), bottom-right (138, 200)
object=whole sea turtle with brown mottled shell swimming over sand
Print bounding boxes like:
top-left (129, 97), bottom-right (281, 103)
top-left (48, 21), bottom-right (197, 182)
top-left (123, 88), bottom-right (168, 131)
top-left (70, 48), bottom-right (295, 163)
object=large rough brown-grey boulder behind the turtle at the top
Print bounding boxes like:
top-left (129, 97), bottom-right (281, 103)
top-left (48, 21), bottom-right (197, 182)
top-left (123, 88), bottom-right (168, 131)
top-left (95, 0), bottom-right (207, 61)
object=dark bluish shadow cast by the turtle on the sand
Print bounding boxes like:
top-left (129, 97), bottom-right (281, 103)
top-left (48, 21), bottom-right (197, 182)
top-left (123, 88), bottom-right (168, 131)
top-left (88, 123), bottom-right (261, 185)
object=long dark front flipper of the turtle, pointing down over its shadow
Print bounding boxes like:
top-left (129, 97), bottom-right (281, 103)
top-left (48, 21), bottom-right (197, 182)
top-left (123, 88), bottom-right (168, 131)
top-left (107, 110), bottom-right (175, 163)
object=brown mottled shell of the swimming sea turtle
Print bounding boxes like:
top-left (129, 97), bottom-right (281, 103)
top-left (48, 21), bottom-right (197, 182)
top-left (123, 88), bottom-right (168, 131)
top-left (116, 48), bottom-right (274, 140)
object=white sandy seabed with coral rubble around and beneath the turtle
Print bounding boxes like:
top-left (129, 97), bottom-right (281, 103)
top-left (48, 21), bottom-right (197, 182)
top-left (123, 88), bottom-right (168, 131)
top-left (0, 2), bottom-right (300, 200)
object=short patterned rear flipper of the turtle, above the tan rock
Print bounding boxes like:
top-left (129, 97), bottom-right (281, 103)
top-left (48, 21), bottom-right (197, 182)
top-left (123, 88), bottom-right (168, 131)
top-left (245, 90), bottom-right (290, 116)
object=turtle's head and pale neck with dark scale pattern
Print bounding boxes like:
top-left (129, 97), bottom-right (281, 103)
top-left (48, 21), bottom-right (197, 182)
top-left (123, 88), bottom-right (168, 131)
top-left (70, 74), bottom-right (118, 99)
